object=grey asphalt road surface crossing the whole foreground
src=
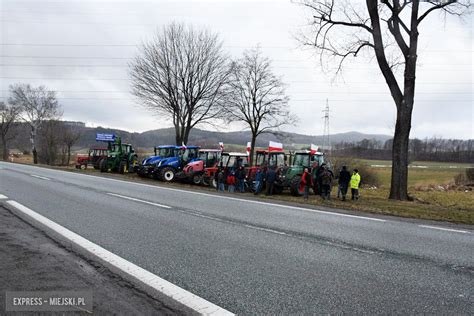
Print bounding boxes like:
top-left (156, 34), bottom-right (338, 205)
top-left (0, 163), bottom-right (474, 315)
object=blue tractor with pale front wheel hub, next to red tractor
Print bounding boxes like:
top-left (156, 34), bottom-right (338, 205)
top-left (155, 146), bottom-right (199, 182)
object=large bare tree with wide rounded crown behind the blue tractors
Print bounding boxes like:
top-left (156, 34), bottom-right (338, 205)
top-left (130, 23), bottom-right (229, 145)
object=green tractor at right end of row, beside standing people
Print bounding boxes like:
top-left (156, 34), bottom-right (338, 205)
top-left (275, 150), bottom-right (324, 196)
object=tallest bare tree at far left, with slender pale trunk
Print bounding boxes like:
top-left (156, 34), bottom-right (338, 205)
top-left (9, 84), bottom-right (62, 164)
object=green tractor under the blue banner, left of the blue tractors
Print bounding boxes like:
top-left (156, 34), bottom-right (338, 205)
top-left (99, 137), bottom-right (138, 174)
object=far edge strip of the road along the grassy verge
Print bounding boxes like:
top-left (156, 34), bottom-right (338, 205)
top-left (1, 162), bottom-right (474, 233)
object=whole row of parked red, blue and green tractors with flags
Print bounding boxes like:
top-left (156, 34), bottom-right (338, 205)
top-left (76, 134), bottom-right (329, 196)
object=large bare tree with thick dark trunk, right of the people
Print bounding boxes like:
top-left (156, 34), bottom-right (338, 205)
top-left (300, 0), bottom-right (469, 200)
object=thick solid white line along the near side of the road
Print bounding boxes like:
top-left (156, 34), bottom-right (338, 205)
top-left (7, 201), bottom-right (234, 315)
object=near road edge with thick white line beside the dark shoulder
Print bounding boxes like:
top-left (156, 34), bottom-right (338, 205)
top-left (0, 196), bottom-right (234, 315)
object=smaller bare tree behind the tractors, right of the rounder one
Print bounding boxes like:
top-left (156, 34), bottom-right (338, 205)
top-left (226, 47), bottom-right (296, 165)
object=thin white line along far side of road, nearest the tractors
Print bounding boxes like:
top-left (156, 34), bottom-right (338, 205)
top-left (0, 166), bottom-right (387, 222)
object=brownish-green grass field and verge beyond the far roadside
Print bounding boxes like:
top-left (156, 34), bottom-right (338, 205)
top-left (4, 157), bottom-right (474, 225)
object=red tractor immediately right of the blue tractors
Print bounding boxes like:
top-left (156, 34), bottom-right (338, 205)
top-left (182, 149), bottom-right (222, 185)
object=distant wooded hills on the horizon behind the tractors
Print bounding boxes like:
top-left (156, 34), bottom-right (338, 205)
top-left (11, 122), bottom-right (391, 149)
